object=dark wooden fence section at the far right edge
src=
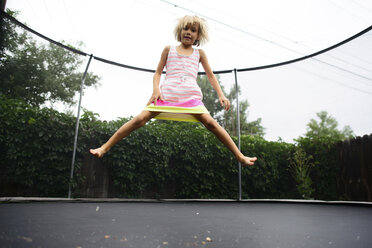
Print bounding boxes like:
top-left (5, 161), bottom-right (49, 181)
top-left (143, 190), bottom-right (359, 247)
top-left (338, 134), bottom-right (372, 202)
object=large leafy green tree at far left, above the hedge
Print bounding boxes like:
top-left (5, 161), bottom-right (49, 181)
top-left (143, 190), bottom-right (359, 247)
top-left (0, 11), bottom-right (99, 106)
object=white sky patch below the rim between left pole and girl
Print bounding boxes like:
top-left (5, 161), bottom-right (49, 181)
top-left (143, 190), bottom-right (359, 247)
top-left (82, 60), bottom-right (153, 120)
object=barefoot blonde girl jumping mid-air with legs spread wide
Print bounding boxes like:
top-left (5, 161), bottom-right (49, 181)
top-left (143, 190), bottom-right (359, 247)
top-left (90, 16), bottom-right (257, 166)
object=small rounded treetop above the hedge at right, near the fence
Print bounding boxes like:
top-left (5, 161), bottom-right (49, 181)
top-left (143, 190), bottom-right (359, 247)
top-left (305, 111), bottom-right (354, 141)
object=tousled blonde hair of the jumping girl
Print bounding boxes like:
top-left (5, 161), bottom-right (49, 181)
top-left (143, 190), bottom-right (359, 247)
top-left (174, 15), bottom-right (209, 46)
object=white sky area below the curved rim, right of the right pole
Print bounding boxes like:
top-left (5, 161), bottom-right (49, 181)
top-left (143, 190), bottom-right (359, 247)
top-left (239, 28), bottom-right (372, 141)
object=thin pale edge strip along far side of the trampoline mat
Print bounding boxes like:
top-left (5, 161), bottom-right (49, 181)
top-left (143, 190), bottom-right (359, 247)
top-left (0, 197), bottom-right (372, 207)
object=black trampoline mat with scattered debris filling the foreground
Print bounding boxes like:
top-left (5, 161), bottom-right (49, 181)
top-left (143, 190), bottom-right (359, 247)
top-left (0, 199), bottom-right (372, 248)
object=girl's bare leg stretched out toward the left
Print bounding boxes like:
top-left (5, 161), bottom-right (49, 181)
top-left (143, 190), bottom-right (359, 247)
top-left (90, 110), bottom-right (159, 158)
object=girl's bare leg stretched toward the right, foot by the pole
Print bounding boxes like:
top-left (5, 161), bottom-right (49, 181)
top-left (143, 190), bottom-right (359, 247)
top-left (194, 114), bottom-right (257, 166)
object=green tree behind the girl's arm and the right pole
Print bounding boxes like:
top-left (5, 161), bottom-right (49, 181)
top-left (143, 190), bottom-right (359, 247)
top-left (197, 75), bottom-right (265, 136)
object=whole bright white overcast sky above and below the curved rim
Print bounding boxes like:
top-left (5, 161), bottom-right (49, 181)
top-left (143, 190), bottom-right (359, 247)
top-left (6, 0), bottom-right (372, 142)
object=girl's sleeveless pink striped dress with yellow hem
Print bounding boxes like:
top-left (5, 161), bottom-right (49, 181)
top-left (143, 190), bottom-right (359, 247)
top-left (145, 46), bottom-right (208, 122)
